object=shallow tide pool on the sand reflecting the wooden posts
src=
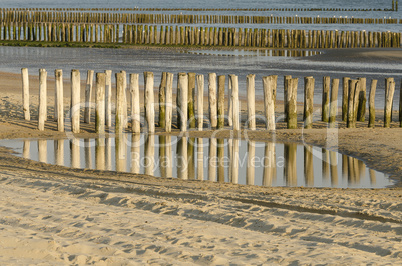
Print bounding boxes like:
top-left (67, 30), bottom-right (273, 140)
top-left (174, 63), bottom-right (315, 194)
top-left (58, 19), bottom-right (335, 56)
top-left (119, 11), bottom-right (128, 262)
top-left (0, 134), bottom-right (395, 188)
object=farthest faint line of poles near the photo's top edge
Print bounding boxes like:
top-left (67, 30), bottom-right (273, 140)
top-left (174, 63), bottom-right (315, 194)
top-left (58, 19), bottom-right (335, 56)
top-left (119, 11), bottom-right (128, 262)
top-left (0, 5), bottom-right (398, 11)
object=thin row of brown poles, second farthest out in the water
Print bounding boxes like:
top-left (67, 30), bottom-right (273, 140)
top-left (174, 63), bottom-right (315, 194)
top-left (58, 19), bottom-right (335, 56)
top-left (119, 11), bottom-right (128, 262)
top-left (0, 11), bottom-right (402, 24)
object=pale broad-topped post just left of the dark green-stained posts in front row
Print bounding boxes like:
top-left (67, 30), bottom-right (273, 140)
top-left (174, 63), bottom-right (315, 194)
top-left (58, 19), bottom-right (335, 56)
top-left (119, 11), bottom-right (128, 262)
top-left (262, 76), bottom-right (276, 130)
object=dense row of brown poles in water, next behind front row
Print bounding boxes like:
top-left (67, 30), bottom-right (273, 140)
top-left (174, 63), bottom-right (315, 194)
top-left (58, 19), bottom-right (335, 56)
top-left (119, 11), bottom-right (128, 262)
top-left (0, 23), bottom-right (402, 48)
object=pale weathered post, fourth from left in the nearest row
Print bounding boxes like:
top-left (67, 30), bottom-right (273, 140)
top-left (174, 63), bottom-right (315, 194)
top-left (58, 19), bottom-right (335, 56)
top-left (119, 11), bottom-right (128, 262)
top-left (70, 69), bottom-right (81, 133)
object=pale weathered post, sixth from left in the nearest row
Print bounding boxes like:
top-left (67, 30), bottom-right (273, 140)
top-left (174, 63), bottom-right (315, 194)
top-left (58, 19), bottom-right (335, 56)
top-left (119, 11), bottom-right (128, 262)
top-left (95, 70), bottom-right (106, 134)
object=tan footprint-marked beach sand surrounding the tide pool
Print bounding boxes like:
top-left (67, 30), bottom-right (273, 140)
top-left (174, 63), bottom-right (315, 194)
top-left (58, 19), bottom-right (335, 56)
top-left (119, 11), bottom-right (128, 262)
top-left (0, 69), bottom-right (402, 265)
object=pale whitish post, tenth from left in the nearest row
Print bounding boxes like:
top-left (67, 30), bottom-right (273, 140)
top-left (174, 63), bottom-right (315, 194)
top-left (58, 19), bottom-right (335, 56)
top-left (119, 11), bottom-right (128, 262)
top-left (144, 72), bottom-right (155, 133)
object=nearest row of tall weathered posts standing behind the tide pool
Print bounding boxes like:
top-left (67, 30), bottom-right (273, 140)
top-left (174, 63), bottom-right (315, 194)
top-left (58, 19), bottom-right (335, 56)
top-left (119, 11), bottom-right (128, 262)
top-left (21, 68), bottom-right (402, 133)
